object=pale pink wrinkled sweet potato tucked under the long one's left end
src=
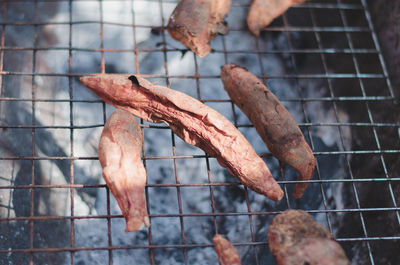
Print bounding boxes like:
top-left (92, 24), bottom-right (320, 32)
top-left (98, 109), bottom-right (150, 232)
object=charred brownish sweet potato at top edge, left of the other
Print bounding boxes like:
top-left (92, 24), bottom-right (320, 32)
top-left (167, 0), bottom-right (231, 57)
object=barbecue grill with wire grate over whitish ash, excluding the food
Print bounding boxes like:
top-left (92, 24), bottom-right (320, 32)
top-left (0, 0), bottom-right (400, 265)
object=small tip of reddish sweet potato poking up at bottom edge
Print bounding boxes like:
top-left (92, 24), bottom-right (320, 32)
top-left (213, 234), bottom-right (242, 265)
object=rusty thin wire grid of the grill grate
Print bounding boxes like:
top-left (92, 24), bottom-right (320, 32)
top-left (0, 0), bottom-right (400, 264)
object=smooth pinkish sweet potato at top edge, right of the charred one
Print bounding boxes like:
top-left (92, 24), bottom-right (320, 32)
top-left (247, 0), bottom-right (306, 37)
